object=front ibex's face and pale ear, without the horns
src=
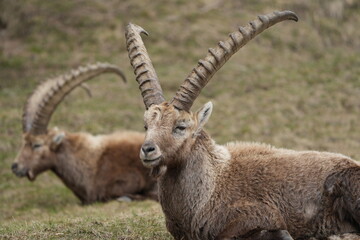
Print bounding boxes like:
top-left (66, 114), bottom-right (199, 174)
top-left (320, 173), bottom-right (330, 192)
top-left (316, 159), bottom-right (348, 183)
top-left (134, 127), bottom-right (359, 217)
top-left (140, 102), bottom-right (212, 167)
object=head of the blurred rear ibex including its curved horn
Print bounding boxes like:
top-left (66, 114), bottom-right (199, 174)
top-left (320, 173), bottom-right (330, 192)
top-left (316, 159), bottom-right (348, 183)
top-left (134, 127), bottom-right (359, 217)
top-left (11, 63), bottom-right (125, 180)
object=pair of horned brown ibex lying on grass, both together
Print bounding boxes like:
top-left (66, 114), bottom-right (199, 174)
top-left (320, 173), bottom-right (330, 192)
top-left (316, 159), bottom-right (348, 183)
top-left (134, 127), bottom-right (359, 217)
top-left (13, 11), bottom-right (360, 240)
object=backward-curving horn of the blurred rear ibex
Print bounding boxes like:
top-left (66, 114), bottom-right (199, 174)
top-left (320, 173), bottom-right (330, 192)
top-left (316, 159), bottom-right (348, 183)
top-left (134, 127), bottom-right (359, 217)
top-left (22, 63), bottom-right (126, 134)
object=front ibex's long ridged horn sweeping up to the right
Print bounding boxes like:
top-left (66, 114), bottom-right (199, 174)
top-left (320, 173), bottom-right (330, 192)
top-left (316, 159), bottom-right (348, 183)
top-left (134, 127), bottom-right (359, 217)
top-left (171, 11), bottom-right (298, 111)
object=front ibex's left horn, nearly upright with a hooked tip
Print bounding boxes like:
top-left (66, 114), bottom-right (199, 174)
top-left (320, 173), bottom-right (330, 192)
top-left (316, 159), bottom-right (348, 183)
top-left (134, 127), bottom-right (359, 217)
top-left (125, 23), bottom-right (165, 109)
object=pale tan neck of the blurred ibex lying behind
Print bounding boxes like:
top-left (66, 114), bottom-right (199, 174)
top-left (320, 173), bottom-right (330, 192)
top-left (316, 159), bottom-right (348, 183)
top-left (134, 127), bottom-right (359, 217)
top-left (54, 133), bottom-right (98, 203)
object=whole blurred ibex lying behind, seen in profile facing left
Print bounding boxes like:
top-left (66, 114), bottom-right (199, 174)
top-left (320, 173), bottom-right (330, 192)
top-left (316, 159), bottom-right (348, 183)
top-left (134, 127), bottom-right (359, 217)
top-left (12, 63), bottom-right (157, 204)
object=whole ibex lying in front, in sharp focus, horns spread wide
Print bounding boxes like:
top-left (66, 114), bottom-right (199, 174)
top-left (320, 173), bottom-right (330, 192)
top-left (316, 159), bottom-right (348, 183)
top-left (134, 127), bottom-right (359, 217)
top-left (126, 11), bottom-right (360, 240)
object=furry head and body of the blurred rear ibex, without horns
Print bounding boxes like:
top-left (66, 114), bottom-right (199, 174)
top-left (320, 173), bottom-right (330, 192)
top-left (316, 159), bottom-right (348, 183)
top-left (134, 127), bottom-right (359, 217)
top-left (13, 129), bottom-right (157, 204)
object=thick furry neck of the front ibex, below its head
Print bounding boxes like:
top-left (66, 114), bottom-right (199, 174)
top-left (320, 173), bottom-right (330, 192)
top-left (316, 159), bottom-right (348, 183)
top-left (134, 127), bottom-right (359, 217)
top-left (159, 132), bottom-right (230, 235)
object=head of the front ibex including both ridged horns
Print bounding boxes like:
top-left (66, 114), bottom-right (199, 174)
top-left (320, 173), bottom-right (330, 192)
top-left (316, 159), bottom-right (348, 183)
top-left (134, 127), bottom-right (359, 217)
top-left (125, 11), bottom-right (298, 172)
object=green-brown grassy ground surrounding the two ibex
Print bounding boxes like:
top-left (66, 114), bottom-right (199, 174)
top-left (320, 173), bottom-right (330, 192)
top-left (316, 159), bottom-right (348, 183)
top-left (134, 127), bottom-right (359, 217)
top-left (0, 0), bottom-right (360, 239)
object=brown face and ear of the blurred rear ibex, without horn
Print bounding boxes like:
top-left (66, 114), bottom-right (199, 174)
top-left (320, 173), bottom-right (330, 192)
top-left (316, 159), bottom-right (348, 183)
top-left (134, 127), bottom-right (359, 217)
top-left (11, 129), bottom-right (64, 181)
